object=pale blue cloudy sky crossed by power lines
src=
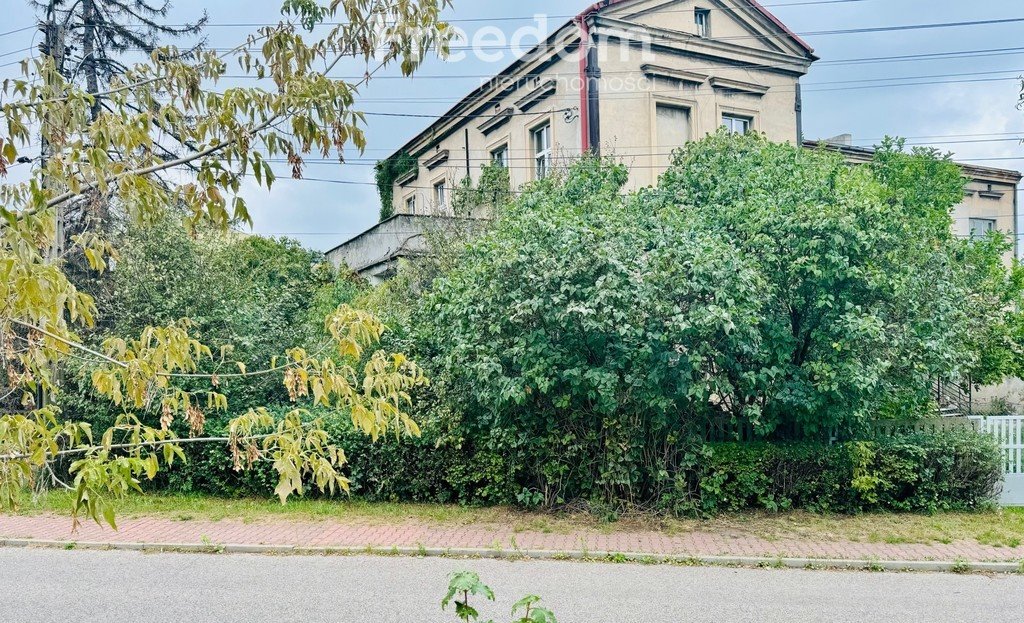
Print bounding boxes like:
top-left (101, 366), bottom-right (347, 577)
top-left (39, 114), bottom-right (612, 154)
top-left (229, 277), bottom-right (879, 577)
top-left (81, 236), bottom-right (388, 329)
top-left (0, 0), bottom-right (1024, 250)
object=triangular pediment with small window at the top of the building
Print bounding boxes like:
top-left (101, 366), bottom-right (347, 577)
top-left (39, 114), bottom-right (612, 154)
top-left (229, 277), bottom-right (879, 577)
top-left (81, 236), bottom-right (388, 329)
top-left (601, 0), bottom-right (811, 56)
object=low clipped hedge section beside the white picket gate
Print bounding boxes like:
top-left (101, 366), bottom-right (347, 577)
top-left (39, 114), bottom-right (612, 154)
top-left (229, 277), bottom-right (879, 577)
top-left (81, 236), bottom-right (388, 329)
top-left (663, 429), bottom-right (1002, 513)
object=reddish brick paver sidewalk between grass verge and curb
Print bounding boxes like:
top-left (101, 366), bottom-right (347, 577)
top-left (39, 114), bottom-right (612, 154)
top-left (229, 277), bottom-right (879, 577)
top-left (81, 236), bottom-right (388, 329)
top-left (0, 515), bottom-right (1024, 563)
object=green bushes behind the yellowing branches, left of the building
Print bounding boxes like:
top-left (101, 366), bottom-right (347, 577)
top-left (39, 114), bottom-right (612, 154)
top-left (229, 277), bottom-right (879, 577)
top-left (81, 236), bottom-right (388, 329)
top-left (60, 217), bottom-right (365, 430)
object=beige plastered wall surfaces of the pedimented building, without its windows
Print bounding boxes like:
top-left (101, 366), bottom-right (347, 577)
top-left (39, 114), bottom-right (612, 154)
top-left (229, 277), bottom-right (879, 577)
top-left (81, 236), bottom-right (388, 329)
top-left (394, 0), bottom-right (813, 215)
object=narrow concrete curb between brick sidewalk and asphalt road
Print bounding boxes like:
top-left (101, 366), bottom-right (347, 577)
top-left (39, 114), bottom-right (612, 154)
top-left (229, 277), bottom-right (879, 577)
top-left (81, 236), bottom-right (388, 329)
top-left (0, 539), bottom-right (1024, 574)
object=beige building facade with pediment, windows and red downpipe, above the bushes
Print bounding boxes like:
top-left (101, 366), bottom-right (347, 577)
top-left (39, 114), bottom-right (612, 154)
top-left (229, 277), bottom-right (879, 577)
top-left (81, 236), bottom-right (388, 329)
top-left (385, 0), bottom-right (816, 215)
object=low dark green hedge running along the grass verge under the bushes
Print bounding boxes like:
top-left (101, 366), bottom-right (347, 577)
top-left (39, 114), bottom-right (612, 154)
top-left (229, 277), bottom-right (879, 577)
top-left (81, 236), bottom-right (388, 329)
top-left (149, 418), bottom-right (1002, 515)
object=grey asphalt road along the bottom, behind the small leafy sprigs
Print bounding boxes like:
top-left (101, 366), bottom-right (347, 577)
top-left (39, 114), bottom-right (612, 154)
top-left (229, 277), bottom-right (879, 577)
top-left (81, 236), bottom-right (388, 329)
top-left (0, 549), bottom-right (1024, 623)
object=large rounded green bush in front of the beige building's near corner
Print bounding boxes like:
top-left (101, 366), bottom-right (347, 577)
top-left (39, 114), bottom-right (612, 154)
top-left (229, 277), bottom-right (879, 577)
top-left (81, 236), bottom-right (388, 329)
top-left (412, 155), bottom-right (760, 505)
